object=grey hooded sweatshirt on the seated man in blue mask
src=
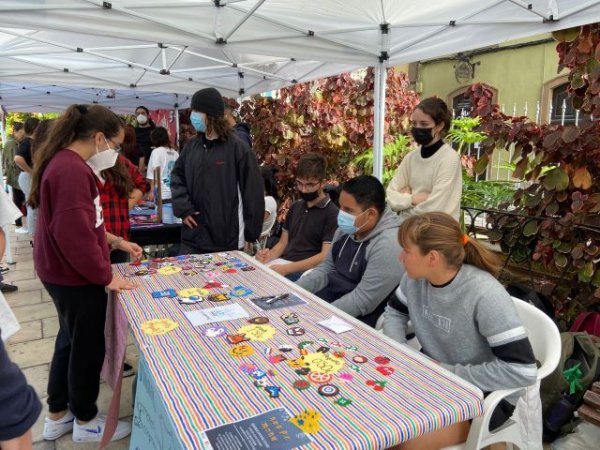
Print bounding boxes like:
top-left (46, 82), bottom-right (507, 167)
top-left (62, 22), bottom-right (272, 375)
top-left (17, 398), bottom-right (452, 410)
top-left (296, 207), bottom-right (404, 325)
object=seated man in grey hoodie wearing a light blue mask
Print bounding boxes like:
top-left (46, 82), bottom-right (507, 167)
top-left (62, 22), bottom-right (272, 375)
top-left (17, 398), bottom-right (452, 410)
top-left (296, 175), bottom-right (404, 326)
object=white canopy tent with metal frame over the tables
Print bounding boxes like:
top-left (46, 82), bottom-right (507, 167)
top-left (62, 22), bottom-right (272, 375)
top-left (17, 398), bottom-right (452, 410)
top-left (0, 0), bottom-right (600, 176)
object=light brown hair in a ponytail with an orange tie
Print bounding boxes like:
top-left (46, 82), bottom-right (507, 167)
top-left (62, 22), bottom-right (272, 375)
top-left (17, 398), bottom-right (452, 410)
top-left (398, 212), bottom-right (501, 278)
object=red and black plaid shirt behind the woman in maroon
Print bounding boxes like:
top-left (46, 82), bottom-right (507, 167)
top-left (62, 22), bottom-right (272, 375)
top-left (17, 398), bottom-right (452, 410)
top-left (96, 155), bottom-right (150, 241)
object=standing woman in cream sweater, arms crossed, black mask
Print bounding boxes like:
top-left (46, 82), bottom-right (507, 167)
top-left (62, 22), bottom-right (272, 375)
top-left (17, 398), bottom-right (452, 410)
top-left (386, 97), bottom-right (462, 220)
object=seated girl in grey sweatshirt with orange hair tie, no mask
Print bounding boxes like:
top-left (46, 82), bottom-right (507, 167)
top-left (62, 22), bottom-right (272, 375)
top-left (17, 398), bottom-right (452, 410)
top-left (383, 212), bottom-right (537, 448)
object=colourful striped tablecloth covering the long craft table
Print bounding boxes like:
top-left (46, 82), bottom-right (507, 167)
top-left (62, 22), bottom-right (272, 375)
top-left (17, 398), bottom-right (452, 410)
top-left (114, 252), bottom-right (483, 449)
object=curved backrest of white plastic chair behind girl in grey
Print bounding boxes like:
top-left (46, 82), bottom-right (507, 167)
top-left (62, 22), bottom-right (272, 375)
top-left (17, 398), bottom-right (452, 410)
top-left (513, 297), bottom-right (561, 380)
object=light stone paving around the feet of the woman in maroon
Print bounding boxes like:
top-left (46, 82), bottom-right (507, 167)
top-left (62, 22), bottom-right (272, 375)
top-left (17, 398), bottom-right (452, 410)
top-left (4, 231), bottom-right (137, 450)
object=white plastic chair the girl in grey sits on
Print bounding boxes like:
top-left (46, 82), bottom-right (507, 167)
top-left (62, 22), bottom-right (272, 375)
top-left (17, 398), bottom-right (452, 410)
top-left (443, 297), bottom-right (561, 450)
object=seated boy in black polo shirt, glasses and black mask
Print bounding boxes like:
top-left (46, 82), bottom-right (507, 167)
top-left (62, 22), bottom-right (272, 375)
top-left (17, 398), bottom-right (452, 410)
top-left (256, 153), bottom-right (339, 281)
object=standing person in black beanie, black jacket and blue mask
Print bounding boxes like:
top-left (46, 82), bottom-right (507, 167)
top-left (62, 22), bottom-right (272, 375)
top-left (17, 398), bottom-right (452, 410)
top-left (171, 88), bottom-right (265, 253)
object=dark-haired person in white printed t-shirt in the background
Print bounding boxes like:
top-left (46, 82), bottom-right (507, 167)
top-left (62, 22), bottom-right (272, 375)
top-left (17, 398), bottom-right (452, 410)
top-left (146, 127), bottom-right (179, 203)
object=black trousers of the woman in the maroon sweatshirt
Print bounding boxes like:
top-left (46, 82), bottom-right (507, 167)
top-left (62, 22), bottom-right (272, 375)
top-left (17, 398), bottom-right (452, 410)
top-left (44, 282), bottom-right (107, 422)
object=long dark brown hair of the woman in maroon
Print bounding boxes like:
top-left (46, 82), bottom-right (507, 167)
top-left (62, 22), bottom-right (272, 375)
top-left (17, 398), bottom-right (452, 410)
top-left (28, 105), bottom-right (123, 208)
